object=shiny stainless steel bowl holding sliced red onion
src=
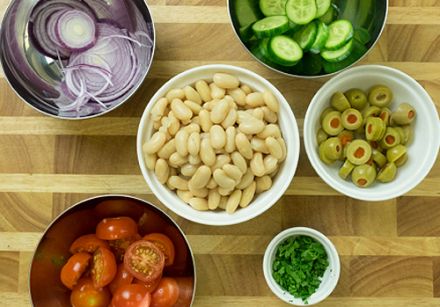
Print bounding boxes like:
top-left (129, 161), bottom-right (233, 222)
top-left (0, 0), bottom-right (156, 119)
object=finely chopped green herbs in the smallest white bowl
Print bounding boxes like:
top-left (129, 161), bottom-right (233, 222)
top-left (272, 236), bottom-right (329, 304)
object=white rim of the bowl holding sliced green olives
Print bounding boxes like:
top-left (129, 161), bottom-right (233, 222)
top-left (303, 65), bottom-right (440, 201)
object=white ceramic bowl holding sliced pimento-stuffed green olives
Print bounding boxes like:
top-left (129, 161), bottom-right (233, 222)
top-left (304, 65), bottom-right (440, 201)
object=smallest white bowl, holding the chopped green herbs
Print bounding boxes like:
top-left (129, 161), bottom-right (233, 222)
top-left (263, 227), bottom-right (341, 306)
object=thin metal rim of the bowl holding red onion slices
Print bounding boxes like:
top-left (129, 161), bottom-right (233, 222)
top-left (0, 0), bottom-right (156, 121)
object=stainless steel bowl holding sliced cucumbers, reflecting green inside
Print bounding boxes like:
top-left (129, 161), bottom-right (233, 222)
top-left (228, 0), bottom-right (388, 79)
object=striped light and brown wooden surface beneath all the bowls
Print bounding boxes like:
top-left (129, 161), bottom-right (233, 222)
top-left (0, 0), bottom-right (440, 307)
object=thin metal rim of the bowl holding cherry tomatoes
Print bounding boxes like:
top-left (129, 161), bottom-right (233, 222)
top-left (27, 194), bottom-right (197, 306)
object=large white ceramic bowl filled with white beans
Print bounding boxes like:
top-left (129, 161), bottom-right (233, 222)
top-left (137, 64), bottom-right (300, 225)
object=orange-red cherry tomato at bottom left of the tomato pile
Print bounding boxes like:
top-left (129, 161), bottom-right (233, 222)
top-left (70, 277), bottom-right (110, 307)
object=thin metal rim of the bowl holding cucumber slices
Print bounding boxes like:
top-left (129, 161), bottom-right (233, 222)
top-left (226, 0), bottom-right (389, 80)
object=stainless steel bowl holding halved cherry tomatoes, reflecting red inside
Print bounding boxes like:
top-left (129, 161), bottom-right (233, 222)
top-left (29, 195), bottom-right (196, 307)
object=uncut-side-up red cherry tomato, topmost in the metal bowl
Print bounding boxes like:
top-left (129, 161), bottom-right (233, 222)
top-left (96, 216), bottom-right (137, 240)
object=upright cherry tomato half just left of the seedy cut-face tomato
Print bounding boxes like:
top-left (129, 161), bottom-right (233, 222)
top-left (92, 247), bottom-right (116, 288)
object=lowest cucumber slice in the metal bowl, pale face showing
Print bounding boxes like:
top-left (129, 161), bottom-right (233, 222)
top-left (268, 35), bottom-right (303, 66)
